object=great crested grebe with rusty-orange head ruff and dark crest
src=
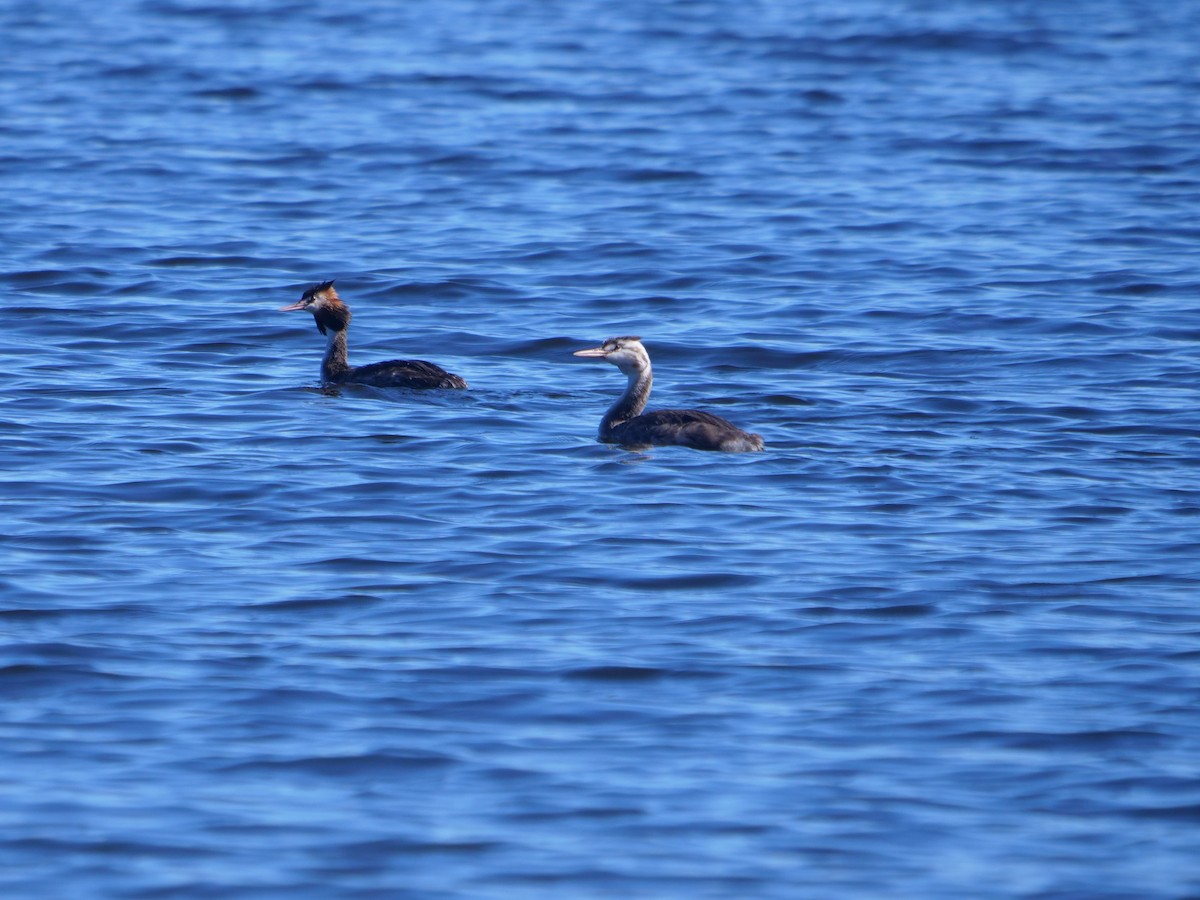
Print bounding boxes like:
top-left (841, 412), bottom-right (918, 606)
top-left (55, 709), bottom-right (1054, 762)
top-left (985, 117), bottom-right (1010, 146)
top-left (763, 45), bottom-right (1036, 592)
top-left (280, 281), bottom-right (467, 388)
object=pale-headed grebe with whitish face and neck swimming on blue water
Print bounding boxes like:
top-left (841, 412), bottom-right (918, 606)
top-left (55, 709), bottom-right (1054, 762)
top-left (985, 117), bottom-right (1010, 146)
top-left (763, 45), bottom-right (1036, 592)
top-left (575, 337), bottom-right (762, 452)
